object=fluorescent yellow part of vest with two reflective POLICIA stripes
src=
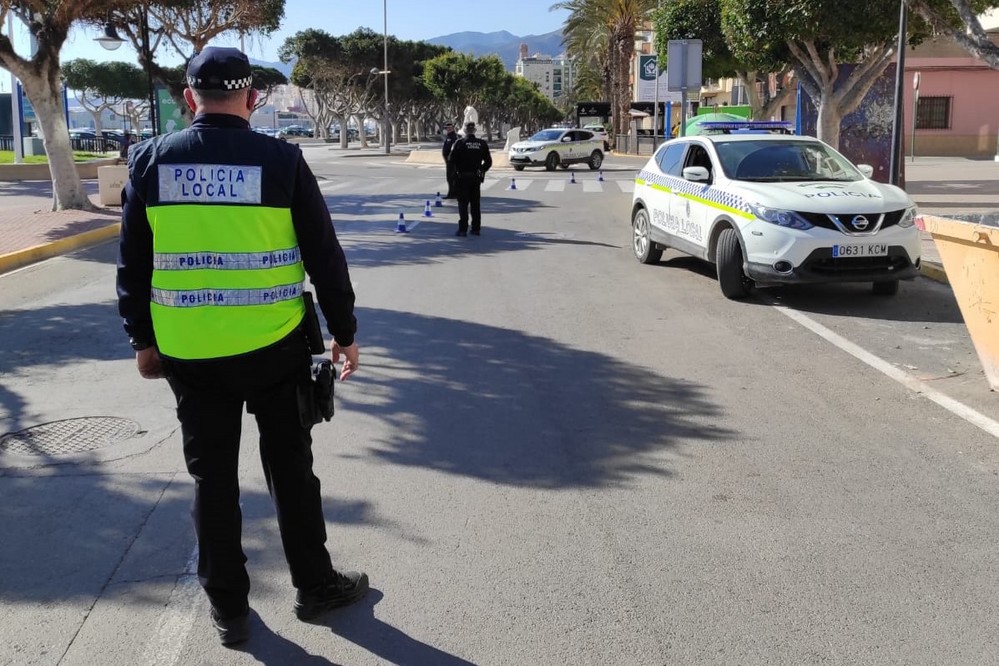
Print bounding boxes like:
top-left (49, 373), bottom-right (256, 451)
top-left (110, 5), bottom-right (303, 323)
top-left (146, 203), bottom-right (305, 360)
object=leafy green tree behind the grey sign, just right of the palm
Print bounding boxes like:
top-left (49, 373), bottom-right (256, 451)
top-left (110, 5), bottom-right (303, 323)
top-left (653, 0), bottom-right (792, 118)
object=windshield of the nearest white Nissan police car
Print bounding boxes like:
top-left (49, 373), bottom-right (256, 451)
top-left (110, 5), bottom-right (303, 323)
top-left (715, 140), bottom-right (864, 182)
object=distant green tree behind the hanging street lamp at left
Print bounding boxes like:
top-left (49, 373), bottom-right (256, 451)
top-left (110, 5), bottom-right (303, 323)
top-left (62, 58), bottom-right (149, 136)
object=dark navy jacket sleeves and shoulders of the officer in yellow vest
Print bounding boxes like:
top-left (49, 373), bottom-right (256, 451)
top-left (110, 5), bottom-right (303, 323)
top-left (118, 114), bottom-right (357, 347)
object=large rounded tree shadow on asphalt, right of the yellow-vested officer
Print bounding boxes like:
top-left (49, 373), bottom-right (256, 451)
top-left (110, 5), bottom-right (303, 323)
top-left (345, 309), bottom-right (737, 489)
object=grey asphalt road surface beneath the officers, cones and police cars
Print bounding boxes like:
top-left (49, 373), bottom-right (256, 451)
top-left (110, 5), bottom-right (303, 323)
top-left (0, 146), bottom-right (999, 666)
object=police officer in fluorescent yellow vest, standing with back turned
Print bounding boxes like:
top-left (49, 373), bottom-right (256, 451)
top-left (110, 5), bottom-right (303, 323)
top-left (117, 47), bottom-right (368, 645)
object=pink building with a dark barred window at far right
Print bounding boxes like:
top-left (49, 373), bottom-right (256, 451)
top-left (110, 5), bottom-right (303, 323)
top-left (903, 28), bottom-right (999, 159)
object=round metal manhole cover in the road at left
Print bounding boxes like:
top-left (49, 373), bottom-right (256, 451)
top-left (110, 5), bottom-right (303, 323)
top-left (0, 416), bottom-right (141, 456)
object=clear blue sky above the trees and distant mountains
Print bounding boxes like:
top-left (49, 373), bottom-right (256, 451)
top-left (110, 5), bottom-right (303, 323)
top-left (43, 0), bottom-right (568, 64)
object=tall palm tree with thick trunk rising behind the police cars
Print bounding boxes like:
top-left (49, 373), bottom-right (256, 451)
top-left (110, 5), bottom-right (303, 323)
top-left (552, 0), bottom-right (658, 134)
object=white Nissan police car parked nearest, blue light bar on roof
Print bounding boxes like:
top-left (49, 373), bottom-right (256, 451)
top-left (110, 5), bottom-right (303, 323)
top-left (631, 122), bottom-right (920, 298)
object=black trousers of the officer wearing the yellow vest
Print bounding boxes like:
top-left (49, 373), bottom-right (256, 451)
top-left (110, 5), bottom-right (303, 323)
top-left (164, 330), bottom-right (332, 616)
